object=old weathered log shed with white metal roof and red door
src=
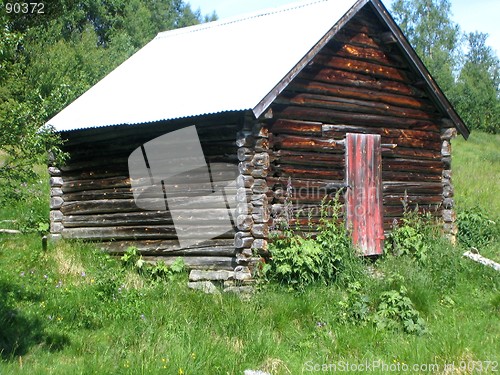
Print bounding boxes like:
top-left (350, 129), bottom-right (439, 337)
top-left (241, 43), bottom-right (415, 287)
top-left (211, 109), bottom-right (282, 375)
top-left (48, 0), bottom-right (469, 270)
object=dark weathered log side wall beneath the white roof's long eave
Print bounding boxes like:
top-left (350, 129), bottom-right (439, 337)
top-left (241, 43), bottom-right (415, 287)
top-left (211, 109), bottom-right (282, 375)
top-left (49, 113), bottom-right (242, 270)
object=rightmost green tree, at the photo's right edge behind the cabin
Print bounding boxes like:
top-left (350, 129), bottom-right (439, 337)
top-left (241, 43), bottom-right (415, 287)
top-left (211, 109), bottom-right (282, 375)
top-left (454, 32), bottom-right (500, 133)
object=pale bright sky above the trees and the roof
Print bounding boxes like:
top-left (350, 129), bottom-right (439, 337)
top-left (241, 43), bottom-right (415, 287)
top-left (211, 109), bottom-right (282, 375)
top-left (185, 0), bottom-right (500, 56)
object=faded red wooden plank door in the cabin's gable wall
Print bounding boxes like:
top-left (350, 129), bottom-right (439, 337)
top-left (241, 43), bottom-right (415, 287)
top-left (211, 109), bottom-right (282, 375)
top-left (345, 133), bottom-right (384, 256)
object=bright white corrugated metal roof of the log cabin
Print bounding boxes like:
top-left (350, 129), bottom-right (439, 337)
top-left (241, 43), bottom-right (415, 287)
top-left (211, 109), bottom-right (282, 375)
top-left (47, 0), bottom-right (356, 131)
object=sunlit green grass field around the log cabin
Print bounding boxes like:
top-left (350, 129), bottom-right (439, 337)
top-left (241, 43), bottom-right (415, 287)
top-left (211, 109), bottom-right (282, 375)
top-left (0, 133), bottom-right (500, 375)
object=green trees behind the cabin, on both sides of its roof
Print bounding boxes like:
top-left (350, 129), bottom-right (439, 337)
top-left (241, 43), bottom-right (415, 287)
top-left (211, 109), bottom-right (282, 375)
top-left (0, 0), bottom-right (500, 201)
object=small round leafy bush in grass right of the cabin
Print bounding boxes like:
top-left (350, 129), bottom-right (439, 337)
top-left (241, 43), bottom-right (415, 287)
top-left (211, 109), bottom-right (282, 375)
top-left (457, 207), bottom-right (499, 247)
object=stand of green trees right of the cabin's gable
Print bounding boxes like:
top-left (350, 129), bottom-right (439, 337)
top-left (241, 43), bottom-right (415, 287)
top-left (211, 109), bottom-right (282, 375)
top-left (392, 0), bottom-right (500, 133)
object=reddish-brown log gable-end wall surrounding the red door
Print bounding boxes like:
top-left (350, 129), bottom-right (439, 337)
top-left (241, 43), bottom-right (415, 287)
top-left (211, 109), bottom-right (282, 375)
top-left (263, 5), bottom-right (456, 234)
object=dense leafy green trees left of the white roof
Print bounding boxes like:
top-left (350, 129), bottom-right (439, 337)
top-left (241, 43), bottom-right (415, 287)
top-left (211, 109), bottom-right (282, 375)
top-left (0, 0), bottom-right (213, 202)
